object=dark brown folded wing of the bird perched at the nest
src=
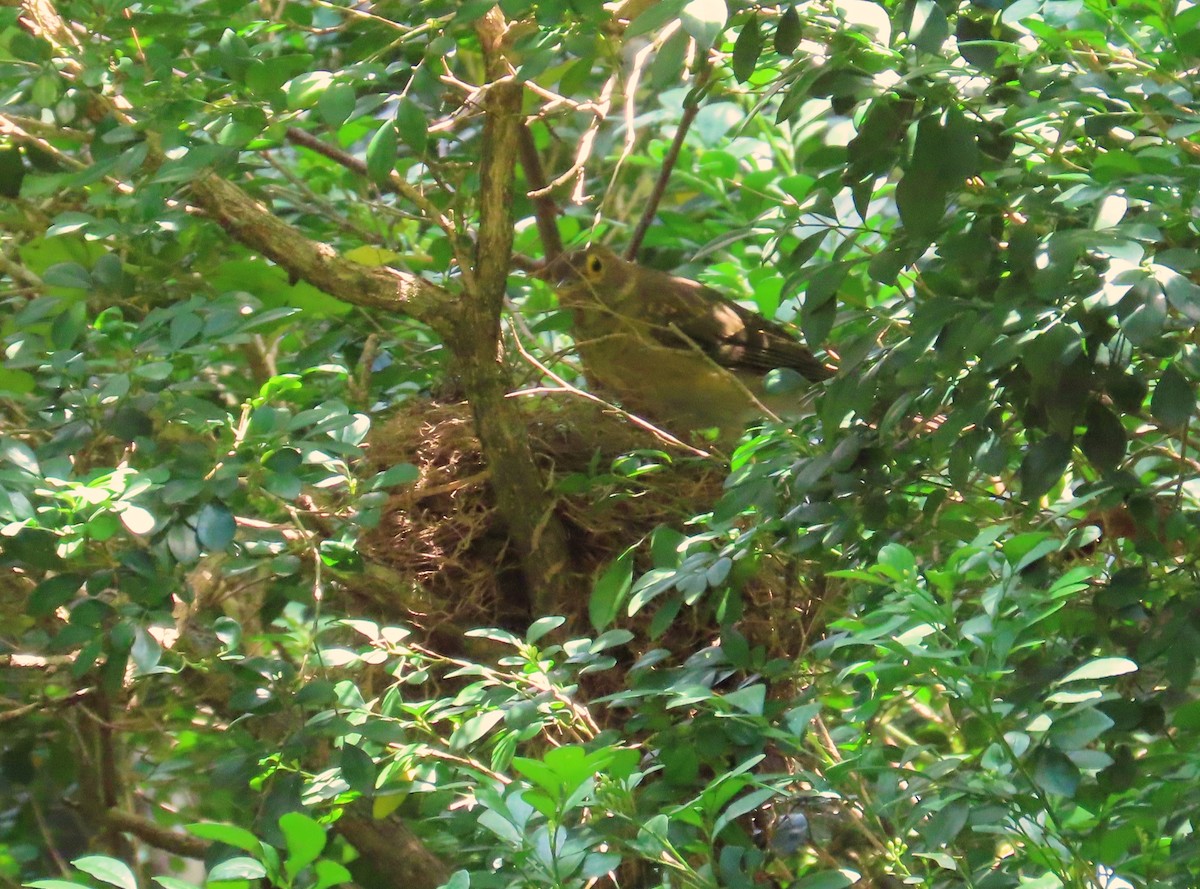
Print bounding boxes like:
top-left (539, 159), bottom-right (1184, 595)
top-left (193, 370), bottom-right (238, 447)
top-left (642, 272), bottom-right (833, 382)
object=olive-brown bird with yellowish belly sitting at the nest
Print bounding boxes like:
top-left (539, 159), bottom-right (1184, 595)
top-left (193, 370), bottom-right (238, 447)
top-left (544, 246), bottom-right (834, 437)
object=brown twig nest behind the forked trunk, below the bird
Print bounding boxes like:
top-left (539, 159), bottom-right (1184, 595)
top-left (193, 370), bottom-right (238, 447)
top-left (352, 397), bottom-right (825, 650)
